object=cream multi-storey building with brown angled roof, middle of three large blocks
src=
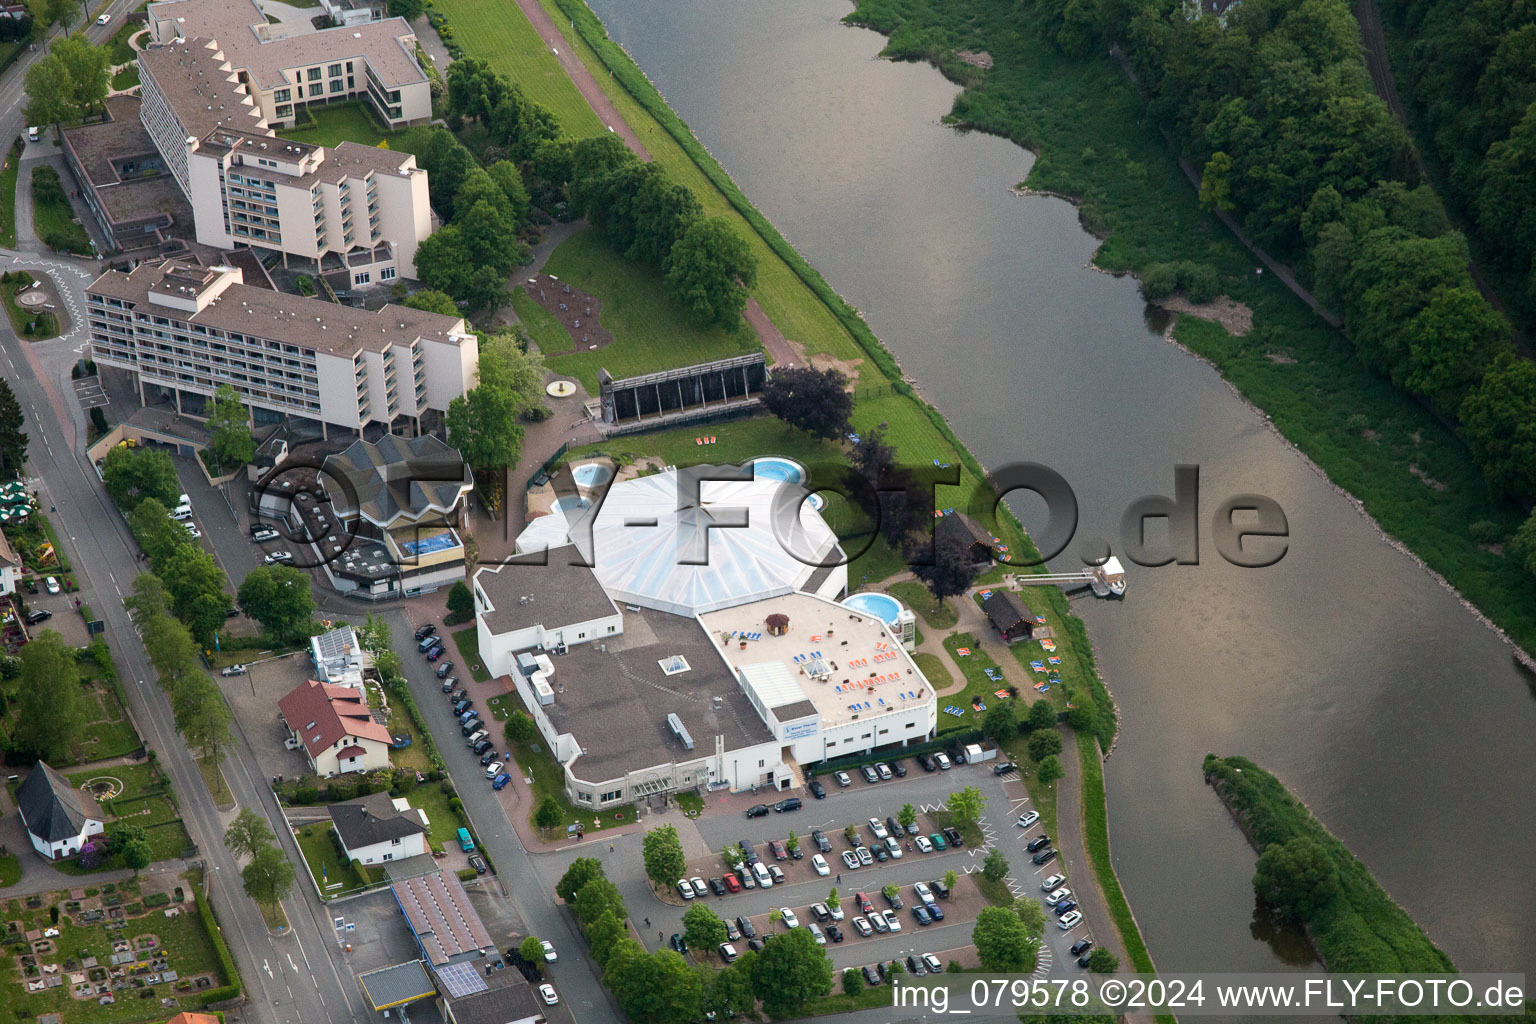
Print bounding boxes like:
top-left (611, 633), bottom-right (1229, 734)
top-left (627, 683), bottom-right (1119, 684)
top-left (140, 40), bottom-right (433, 277)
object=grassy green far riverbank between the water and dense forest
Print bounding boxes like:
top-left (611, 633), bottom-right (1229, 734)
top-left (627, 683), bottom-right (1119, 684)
top-left (845, 0), bottom-right (1536, 648)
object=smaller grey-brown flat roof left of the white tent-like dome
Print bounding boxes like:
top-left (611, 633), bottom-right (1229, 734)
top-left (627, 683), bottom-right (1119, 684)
top-left (475, 545), bottom-right (617, 633)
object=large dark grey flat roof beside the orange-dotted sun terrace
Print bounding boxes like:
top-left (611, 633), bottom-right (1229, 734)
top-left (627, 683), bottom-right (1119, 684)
top-left (544, 608), bottom-right (773, 783)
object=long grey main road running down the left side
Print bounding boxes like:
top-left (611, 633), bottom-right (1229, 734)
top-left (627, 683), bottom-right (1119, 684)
top-left (0, 259), bottom-right (372, 1024)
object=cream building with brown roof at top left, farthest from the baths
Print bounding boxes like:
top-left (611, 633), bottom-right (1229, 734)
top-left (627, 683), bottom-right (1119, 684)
top-left (149, 0), bottom-right (432, 127)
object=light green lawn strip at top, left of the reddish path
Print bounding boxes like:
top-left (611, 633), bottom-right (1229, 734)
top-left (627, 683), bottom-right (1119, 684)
top-left (433, 0), bottom-right (607, 138)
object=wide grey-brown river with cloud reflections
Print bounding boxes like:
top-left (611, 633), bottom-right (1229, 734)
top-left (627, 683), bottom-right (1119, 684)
top-left (580, 0), bottom-right (1536, 970)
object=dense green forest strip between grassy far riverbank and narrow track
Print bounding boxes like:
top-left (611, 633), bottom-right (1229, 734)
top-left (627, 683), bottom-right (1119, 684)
top-left (1031, 0), bottom-right (1536, 543)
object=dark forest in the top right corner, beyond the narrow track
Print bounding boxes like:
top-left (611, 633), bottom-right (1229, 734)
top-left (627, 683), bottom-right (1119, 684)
top-left (1382, 0), bottom-right (1536, 316)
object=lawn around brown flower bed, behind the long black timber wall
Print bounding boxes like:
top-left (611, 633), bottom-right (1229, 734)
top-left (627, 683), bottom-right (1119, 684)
top-left (540, 228), bottom-right (759, 395)
